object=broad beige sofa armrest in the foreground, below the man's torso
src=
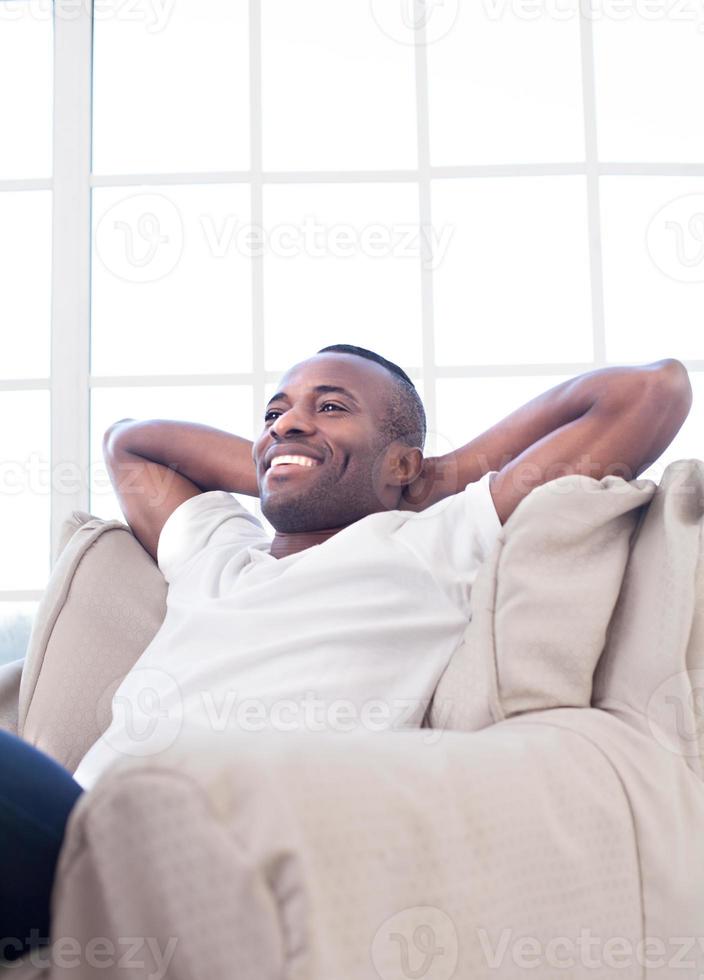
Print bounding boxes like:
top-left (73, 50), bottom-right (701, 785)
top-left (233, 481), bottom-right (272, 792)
top-left (52, 712), bottom-right (642, 980)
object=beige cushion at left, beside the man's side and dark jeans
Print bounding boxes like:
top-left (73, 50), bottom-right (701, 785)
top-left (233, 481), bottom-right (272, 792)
top-left (18, 511), bottom-right (166, 772)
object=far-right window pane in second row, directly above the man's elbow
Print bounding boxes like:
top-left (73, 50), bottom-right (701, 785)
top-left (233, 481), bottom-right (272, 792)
top-left (601, 177), bottom-right (704, 362)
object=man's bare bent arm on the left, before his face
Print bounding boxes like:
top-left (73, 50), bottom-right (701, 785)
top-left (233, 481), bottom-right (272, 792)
top-left (103, 419), bottom-right (259, 561)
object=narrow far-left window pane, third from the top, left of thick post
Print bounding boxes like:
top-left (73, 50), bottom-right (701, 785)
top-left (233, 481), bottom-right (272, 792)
top-left (0, 391), bottom-right (52, 591)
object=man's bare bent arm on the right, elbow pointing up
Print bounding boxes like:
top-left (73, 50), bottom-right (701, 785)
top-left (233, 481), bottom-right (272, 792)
top-left (402, 358), bottom-right (692, 524)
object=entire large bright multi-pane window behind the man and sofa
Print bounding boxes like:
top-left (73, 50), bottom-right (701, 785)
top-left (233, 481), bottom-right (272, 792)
top-left (0, 0), bottom-right (704, 657)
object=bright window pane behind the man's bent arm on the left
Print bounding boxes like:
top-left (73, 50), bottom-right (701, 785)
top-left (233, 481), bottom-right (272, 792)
top-left (90, 385), bottom-right (253, 521)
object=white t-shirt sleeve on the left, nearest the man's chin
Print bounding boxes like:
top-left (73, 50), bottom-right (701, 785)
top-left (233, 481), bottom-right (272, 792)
top-left (156, 490), bottom-right (268, 582)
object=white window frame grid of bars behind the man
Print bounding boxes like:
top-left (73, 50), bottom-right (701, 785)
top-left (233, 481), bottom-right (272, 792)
top-left (0, 0), bottom-right (704, 601)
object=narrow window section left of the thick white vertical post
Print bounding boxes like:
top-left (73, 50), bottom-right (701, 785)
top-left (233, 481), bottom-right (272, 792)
top-left (0, 0), bottom-right (53, 662)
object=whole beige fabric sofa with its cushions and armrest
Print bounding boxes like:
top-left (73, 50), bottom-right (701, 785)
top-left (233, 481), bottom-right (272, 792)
top-left (0, 460), bottom-right (704, 980)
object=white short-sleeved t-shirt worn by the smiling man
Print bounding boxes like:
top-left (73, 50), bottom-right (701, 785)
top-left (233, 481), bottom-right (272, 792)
top-left (75, 473), bottom-right (501, 788)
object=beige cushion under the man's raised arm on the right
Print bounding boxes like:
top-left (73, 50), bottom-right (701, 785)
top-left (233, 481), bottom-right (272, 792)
top-left (429, 474), bottom-right (655, 731)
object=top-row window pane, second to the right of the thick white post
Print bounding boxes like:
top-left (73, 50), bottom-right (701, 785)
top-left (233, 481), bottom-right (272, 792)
top-left (262, 0), bottom-right (418, 170)
